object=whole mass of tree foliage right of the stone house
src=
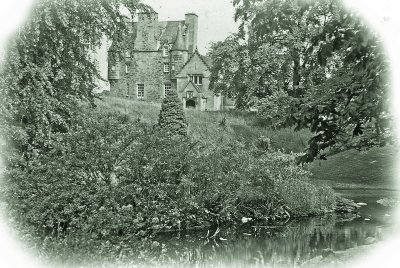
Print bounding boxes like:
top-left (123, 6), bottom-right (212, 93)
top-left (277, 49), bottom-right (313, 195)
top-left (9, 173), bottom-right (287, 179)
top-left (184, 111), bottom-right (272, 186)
top-left (210, 0), bottom-right (391, 162)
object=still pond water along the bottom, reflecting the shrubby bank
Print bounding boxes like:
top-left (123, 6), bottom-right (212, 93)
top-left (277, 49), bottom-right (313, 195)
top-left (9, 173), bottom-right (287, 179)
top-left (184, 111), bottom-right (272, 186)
top-left (125, 190), bottom-right (397, 267)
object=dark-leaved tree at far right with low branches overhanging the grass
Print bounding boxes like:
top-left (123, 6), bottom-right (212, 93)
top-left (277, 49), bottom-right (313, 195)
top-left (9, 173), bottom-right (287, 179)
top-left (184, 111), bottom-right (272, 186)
top-left (295, 4), bottom-right (392, 162)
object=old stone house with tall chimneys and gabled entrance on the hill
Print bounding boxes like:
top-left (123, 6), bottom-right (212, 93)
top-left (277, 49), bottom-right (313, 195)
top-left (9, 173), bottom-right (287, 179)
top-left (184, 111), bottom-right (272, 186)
top-left (108, 12), bottom-right (231, 111)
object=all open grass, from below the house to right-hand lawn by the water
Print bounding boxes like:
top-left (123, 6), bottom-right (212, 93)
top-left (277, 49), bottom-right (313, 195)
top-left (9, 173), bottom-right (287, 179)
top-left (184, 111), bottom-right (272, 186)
top-left (98, 97), bottom-right (400, 189)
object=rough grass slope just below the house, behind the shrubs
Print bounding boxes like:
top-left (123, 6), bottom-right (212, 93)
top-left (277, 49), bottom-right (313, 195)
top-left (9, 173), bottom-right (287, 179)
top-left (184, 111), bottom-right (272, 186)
top-left (97, 97), bottom-right (310, 152)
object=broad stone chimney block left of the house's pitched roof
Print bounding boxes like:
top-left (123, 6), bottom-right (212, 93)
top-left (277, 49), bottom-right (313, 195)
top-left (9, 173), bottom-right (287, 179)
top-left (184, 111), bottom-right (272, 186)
top-left (135, 12), bottom-right (158, 51)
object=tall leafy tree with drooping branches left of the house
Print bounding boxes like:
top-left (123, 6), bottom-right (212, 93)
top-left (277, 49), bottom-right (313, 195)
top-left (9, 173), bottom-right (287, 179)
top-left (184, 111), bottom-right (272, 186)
top-left (0, 0), bottom-right (149, 162)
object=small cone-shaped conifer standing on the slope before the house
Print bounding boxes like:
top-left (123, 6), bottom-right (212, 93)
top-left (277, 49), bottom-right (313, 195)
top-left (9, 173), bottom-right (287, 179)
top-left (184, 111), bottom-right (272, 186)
top-left (158, 90), bottom-right (187, 136)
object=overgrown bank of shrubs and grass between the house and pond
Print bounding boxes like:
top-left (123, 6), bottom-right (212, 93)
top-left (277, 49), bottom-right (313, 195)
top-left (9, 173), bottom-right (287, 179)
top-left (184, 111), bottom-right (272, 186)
top-left (3, 97), bottom-right (358, 262)
